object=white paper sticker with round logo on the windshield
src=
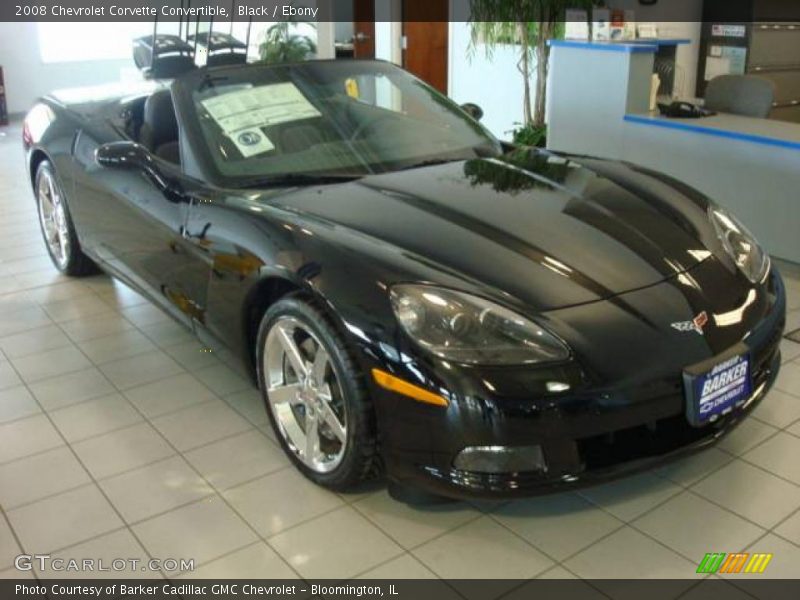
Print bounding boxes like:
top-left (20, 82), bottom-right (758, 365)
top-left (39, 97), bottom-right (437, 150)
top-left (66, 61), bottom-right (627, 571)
top-left (201, 83), bottom-right (321, 158)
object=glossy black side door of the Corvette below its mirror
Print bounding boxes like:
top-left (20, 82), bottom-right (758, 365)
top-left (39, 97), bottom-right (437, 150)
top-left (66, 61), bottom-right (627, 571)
top-left (75, 117), bottom-right (194, 325)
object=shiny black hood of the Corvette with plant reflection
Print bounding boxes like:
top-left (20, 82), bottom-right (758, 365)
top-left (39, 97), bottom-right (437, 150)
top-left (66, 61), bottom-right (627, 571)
top-left (264, 150), bottom-right (716, 310)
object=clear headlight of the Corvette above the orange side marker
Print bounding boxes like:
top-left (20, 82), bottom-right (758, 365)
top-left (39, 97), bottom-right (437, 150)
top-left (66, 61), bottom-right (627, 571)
top-left (390, 285), bottom-right (569, 365)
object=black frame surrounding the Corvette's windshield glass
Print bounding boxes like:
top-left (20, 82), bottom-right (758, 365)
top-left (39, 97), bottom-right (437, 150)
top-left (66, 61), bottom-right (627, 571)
top-left (172, 59), bottom-right (502, 189)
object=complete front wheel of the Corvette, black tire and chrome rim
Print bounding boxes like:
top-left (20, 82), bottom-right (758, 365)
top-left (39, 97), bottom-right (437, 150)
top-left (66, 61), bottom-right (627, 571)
top-left (257, 295), bottom-right (379, 491)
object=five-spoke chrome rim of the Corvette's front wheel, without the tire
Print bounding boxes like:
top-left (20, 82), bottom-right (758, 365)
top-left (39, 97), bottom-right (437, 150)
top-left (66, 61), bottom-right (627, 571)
top-left (263, 316), bottom-right (347, 473)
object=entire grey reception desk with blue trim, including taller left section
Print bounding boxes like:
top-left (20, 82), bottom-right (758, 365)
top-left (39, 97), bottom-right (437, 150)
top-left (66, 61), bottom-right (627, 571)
top-left (547, 38), bottom-right (800, 263)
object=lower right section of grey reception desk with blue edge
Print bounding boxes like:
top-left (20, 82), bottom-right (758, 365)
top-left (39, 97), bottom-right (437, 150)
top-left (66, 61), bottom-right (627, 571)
top-left (620, 113), bottom-right (800, 262)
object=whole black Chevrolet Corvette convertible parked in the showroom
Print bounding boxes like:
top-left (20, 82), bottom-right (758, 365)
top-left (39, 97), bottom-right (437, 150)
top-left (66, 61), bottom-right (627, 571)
top-left (23, 61), bottom-right (785, 498)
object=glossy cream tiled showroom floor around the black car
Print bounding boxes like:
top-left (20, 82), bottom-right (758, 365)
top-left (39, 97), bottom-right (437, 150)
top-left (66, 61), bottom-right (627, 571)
top-left (0, 122), bottom-right (800, 578)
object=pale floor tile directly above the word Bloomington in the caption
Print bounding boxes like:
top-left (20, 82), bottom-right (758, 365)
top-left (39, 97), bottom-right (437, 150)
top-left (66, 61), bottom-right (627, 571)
top-left (269, 506), bottom-right (403, 579)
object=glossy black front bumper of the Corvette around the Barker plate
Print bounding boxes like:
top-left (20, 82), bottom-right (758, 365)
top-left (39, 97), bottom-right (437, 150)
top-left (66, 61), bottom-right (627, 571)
top-left (374, 264), bottom-right (785, 498)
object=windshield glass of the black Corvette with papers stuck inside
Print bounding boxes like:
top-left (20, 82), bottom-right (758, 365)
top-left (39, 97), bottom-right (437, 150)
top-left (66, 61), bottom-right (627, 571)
top-left (177, 60), bottom-right (501, 186)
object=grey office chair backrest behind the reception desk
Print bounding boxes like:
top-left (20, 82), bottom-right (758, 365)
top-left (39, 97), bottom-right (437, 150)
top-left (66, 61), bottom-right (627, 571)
top-left (705, 75), bottom-right (775, 119)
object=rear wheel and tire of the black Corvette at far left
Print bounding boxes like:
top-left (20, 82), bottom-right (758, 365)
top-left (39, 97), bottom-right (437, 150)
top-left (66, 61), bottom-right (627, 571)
top-left (34, 160), bottom-right (98, 277)
